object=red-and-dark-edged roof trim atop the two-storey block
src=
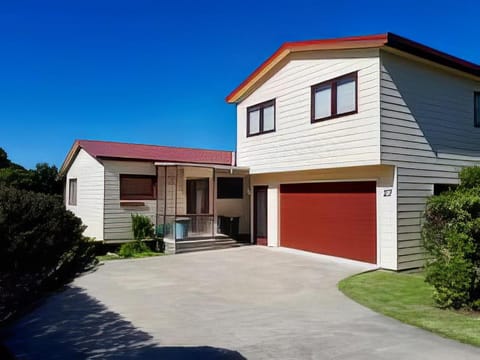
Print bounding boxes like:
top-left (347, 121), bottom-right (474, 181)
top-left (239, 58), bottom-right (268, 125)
top-left (226, 33), bottom-right (480, 103)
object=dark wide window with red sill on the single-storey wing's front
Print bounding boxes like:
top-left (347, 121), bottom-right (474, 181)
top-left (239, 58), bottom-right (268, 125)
top-left (120, 175), bottom-right (156, 200)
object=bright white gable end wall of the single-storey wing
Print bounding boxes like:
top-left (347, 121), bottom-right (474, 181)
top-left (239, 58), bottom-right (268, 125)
top-left (65, 149), bottom-right (104, 240)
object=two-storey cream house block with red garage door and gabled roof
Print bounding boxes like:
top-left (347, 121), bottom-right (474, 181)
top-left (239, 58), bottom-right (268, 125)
top-left (227, 33), bottom-right (480, 270)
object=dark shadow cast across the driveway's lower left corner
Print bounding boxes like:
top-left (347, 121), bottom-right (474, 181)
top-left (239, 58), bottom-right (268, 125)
top-left (4, 287), bottom-right (245, 360)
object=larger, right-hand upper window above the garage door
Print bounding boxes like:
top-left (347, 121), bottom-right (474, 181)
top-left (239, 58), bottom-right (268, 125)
top-left (311, 72), bottom-right (357, 122)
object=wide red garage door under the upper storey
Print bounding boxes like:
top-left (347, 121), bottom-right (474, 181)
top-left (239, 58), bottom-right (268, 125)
top-left (280, 182), bottom-right (377, 263)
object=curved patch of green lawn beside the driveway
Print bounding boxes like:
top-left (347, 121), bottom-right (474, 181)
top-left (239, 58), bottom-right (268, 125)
top-left (338, 270), bottom-right (480, 346)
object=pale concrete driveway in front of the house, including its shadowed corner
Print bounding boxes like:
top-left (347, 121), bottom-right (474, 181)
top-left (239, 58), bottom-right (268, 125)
top-left (3, 246), bottom-right (480, 360)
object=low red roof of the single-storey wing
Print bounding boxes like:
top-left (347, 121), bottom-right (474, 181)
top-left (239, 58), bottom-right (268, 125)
top-left (60, 140), bottom-right (235, 174)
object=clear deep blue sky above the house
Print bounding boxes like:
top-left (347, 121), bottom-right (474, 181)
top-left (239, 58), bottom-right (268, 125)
top-left (0, 0), bottom-right (480, 167)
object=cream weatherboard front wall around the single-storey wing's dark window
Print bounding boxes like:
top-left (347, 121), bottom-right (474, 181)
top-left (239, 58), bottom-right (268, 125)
top-left (102, 160), bottom-right (157, 241)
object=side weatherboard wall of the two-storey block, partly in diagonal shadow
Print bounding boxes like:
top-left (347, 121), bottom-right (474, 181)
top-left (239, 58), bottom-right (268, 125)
top-left (380, 51), bottom-right (480, 270)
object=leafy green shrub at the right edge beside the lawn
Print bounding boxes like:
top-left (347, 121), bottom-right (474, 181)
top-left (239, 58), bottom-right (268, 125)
top-left (422, 167), bottom-right (480, 309)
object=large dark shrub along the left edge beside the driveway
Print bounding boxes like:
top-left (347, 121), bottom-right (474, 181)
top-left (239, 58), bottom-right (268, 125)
top-left (0, 186), bottom-right (95, 322)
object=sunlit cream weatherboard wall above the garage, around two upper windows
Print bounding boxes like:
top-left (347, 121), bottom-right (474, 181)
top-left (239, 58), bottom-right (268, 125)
top-left (237, 49), bottom-right (380, 174)
